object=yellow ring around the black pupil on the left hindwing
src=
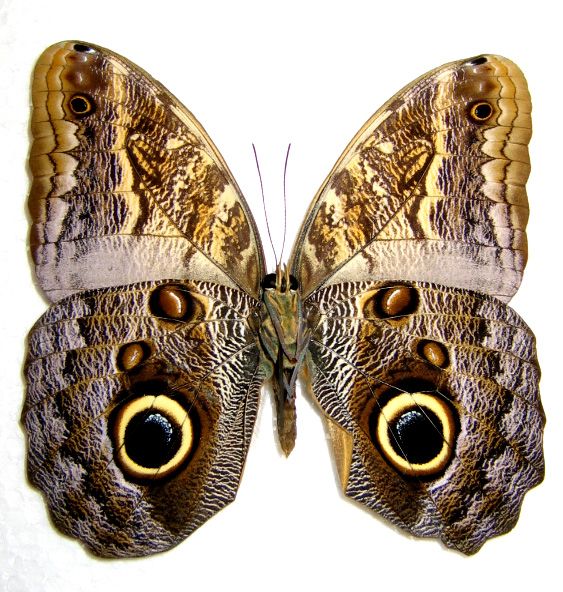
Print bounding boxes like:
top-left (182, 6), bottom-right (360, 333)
top-left (115, 395), bottom-right (193, 479)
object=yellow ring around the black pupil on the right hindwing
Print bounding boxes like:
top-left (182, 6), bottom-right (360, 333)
top-left (376, 393), bottom-right (455, 477)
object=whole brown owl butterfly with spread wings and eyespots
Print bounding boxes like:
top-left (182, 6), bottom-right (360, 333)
top-left (23, 41), bottom-right (544, 557)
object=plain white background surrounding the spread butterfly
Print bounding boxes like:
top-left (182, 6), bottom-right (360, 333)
top-left (0, 0), bottom-right (563, 592)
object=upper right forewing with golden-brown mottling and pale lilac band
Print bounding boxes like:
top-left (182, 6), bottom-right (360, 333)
top-left (291, 55), bottom-right (531, 301)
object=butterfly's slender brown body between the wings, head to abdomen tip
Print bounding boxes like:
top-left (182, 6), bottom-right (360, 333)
top-left (260, 265), bottom-right (308, 455)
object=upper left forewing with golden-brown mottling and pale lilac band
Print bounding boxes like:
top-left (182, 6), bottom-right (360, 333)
top-left (29, 41), bottom-right (264, 301)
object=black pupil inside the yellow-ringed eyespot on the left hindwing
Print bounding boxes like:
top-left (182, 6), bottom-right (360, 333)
top-left (125, 412), bottom-right (181, 469)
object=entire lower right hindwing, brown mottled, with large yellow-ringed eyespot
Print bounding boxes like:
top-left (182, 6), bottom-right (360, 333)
top-left (305, 282), bottom-right (544, 554)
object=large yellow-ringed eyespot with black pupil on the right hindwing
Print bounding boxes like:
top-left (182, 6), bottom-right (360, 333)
top-left (372, 393), bottom-right (457, 478)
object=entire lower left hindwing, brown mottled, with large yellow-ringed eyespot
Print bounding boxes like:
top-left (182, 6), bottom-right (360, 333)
top-left (23, 282), bottom-right (264, 557)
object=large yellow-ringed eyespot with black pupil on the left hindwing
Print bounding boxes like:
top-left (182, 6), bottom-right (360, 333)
top-left (113, 395), bottom-right (197, 480)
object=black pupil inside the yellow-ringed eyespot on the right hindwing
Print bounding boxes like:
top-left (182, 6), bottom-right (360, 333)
top-left (388, 408), bottom-right (443, 464)
